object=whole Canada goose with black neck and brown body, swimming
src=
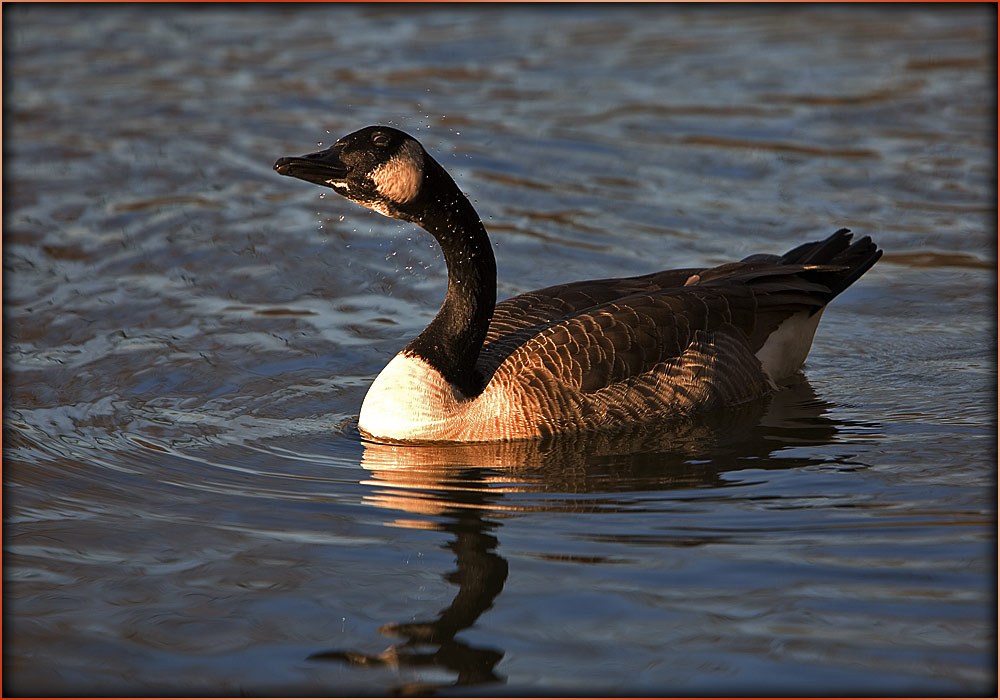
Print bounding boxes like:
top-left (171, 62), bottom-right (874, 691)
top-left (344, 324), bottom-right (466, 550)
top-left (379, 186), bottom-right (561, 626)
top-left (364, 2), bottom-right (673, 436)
top-left (274, 126), bottom-right (882, 441)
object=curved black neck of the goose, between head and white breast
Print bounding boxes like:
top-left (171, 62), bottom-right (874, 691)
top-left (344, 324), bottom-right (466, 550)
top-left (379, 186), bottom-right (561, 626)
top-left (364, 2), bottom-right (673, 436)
top-left (401, 156), bottom-right (497, 396)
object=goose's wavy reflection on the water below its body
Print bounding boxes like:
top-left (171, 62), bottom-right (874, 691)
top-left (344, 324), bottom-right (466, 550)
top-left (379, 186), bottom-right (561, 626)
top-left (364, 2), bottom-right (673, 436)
top-left (309, 376), bottom-right (877, 695)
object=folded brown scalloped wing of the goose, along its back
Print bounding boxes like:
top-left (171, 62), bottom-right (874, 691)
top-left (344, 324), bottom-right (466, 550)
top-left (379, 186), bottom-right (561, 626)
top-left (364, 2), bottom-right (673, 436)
top-left (477, 263), bottom-right (830, 392)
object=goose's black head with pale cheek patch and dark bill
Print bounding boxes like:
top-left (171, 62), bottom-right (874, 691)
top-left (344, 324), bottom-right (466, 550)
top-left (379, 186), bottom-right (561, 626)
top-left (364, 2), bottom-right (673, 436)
top-left (274, 126), bottom-right (430, 219)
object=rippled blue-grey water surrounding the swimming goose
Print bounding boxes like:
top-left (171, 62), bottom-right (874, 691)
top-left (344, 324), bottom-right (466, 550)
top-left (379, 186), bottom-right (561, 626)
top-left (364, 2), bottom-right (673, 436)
top-left (3, 5), bottom-right (996, 695)
